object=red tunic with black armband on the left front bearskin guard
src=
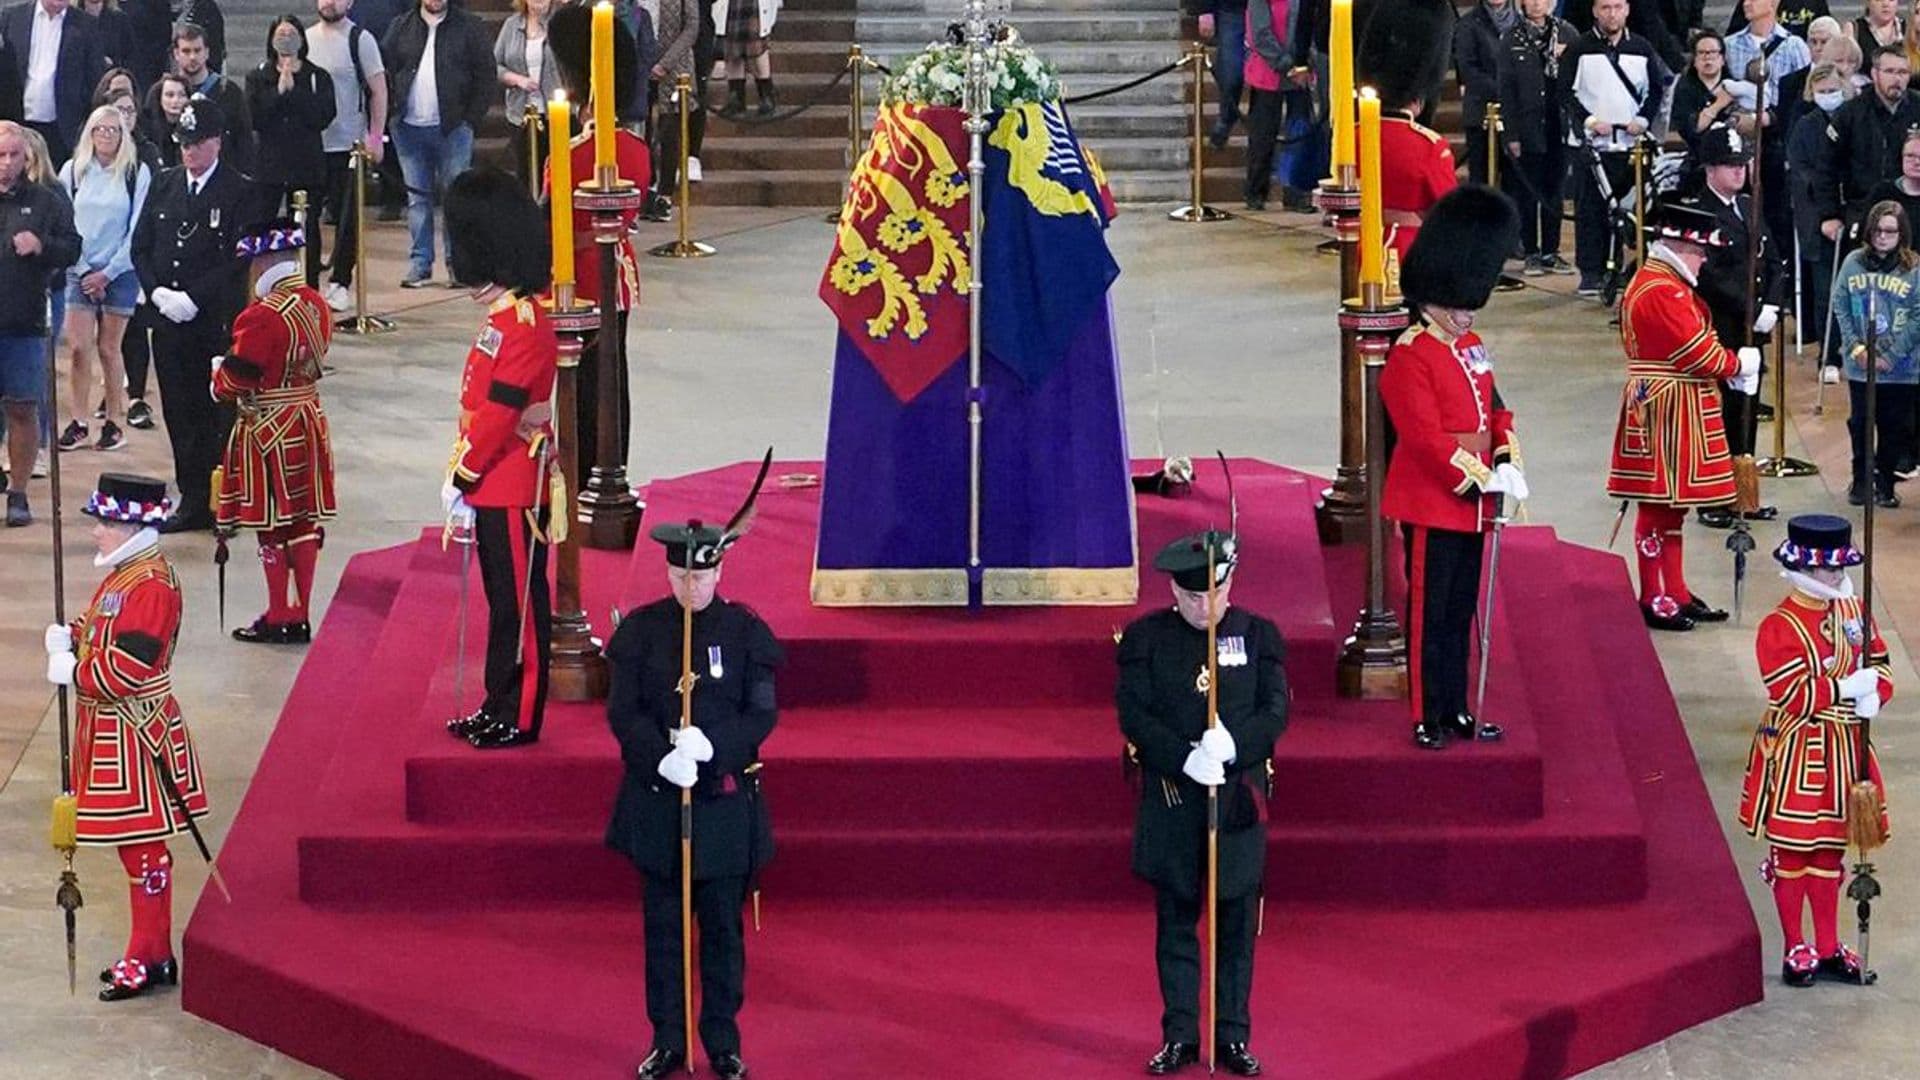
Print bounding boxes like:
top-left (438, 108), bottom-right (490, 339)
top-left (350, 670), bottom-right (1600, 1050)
top-left (451, 292), bottom-right (559, 509)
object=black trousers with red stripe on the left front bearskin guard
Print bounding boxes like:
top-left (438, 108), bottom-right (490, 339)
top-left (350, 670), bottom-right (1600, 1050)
top-left (474, 505), bottom-right (553, 734)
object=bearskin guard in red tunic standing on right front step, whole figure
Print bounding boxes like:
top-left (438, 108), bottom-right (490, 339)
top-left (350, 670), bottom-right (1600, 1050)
top-left (1380, 184), bottom-right (1528, 749)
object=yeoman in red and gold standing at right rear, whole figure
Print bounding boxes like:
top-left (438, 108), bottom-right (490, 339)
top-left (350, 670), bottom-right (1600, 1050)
top-left (1607, 198), bottom-right (1761, 630)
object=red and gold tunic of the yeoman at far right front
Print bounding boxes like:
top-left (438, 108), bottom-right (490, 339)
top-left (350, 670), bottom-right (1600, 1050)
top-left (1740, 590), bottom-right (1893, 851)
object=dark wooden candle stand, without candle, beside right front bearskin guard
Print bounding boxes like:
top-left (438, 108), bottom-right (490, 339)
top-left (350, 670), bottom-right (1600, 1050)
top-left (1336, 284), bottom-right (1409, 700)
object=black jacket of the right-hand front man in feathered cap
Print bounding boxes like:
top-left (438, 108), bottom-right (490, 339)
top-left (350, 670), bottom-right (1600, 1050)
top-left (1116, 607), bottom-right (1286, 897)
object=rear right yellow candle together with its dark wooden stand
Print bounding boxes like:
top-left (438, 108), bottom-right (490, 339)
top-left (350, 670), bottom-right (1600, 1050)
top-left (1313, 0), bottom-right (1367, 544)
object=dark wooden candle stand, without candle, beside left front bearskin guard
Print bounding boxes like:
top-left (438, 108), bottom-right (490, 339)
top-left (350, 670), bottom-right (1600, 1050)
top-left (547, 282), bottom-right (607, 701)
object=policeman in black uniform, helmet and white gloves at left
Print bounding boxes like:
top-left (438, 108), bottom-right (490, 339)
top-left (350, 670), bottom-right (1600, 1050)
top-left (132, 94), bottom-right (259, 532)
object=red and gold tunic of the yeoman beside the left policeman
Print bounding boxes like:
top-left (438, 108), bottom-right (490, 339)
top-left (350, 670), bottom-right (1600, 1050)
top-left (213, 275), bottom-right (338, 528)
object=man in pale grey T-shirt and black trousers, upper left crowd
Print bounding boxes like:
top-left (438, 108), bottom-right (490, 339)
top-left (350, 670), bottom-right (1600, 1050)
top-left (307, 0), bottom-right (386, 311)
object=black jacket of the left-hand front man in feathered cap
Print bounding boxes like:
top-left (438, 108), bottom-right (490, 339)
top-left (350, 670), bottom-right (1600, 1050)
top-left (607, 596), bottom-right (783, 880)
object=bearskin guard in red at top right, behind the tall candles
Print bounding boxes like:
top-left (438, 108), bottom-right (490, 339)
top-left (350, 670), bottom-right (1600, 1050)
top-left (1356, 0), bottom-right (1459, 292)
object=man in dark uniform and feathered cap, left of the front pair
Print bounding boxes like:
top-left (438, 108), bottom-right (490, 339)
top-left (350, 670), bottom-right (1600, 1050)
top-left (607, 500), bottom-right (781, 1080)
